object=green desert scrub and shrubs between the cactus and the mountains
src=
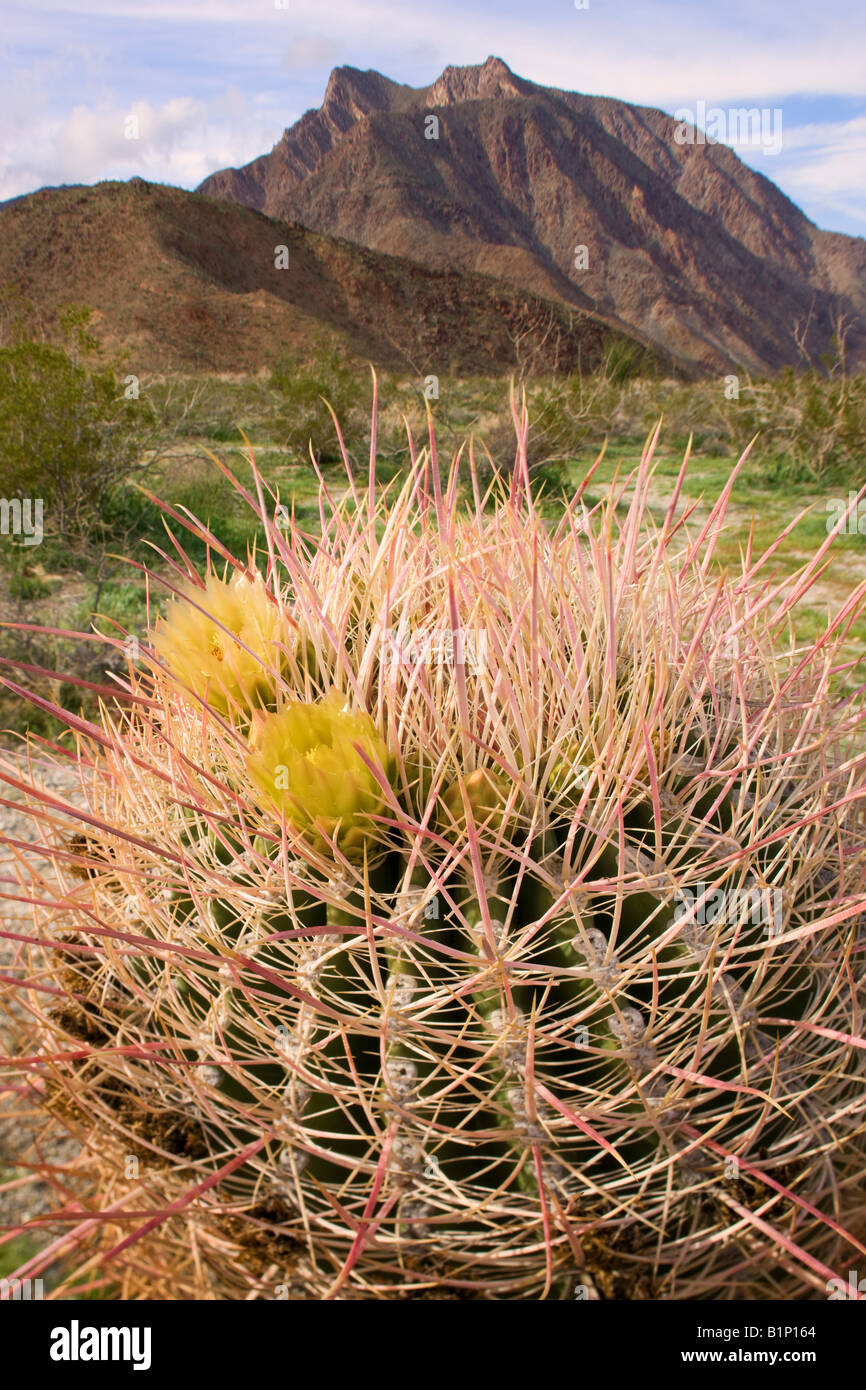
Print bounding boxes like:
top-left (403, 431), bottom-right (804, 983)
top-left (0, 322), bottom-right (866, 731)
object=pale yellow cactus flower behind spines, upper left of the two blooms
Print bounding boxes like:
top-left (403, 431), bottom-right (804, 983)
top-left (154, 574), bottom-right (286, 714)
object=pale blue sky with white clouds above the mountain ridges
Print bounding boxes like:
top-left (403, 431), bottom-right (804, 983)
top-left (0, 0), bottom-right (866, 236)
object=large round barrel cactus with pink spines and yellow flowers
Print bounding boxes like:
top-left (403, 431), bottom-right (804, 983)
top-left (1, 414), bottom-right (866, 1300)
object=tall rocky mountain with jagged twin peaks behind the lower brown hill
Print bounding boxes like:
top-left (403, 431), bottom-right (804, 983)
top-left (200, 57), bottom-right (866, 371)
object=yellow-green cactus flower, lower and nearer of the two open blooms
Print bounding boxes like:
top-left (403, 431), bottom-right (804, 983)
top-left (247, 689), bottom-right (393, 853)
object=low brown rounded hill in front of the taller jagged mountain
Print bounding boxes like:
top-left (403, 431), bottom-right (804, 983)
top-left (0, 179), bottom-right (656, 375)
